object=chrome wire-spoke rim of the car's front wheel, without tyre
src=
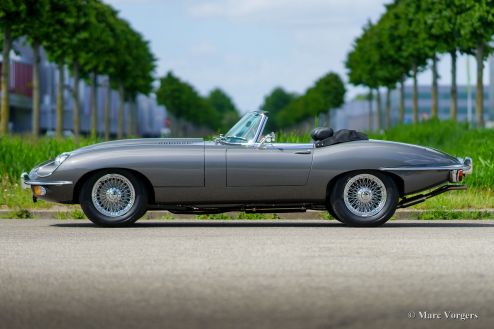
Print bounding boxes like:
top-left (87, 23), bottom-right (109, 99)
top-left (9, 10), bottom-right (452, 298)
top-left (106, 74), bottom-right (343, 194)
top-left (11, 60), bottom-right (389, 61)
top-left (91, 174), bottom-right (136, 218)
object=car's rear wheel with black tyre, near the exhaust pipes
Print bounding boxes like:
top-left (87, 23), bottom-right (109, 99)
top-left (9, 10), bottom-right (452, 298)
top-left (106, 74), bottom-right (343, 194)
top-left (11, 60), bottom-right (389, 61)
top-left (330, 171), bottom-right (399, 227)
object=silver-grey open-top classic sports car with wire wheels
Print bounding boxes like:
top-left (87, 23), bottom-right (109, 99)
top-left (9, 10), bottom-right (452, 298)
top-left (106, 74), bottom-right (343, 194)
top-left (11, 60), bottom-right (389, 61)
top-left (22, 112), bottom-right (472, 226)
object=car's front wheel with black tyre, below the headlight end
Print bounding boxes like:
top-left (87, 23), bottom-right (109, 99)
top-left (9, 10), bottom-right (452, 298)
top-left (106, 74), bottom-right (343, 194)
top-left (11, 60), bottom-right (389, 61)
top-left (79, 170), bottom-right (147, 227)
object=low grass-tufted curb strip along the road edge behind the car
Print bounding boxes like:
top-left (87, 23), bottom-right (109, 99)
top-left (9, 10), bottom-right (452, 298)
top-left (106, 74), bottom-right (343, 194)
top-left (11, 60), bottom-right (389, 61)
top-left (0, 207), bottom-right (494, 220)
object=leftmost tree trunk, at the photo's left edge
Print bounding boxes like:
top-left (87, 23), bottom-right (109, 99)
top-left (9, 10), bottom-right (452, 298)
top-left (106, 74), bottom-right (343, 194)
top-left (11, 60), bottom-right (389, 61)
top-left (0, 25), bottom-right (12, 136)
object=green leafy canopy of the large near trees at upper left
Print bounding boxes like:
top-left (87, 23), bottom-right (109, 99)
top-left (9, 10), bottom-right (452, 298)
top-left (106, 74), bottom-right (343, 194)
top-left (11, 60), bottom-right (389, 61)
top-left (0, 0), bottom-right (156, 136)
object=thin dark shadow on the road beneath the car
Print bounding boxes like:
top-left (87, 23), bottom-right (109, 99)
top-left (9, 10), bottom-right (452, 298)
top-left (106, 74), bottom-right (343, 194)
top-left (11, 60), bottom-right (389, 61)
top-left (51, 221), bottom-right (494, 229)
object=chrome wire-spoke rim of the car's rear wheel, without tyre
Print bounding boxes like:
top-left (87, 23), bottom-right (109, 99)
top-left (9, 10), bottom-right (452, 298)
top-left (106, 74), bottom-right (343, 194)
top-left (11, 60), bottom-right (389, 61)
top-left (343, 174), bottom-right (387, 217)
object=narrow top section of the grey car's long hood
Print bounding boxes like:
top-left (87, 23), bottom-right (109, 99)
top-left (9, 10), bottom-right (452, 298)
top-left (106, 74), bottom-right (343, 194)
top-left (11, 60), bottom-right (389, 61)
top-left (70, 138), bottom-right (204, 155)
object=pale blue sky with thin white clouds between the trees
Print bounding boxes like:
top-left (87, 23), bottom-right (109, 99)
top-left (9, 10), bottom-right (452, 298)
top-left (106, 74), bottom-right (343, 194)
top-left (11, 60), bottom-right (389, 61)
top-left (106, 0), bottom-right (488, 111)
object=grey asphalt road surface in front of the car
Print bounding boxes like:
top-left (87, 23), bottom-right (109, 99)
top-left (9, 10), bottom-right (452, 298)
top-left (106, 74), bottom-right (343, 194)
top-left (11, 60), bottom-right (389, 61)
top-left (0, 220), bottom-right (494, 329)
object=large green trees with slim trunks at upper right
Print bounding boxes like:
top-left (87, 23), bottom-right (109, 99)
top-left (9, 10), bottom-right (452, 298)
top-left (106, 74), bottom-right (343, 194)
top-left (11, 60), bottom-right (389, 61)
top-left (345, 0), bottom-right (494, 125)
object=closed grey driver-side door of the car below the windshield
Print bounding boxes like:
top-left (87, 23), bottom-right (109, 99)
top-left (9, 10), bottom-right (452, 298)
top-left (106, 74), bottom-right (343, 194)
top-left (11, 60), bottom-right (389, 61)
top-left (226, 144), bottom-right (313, 187)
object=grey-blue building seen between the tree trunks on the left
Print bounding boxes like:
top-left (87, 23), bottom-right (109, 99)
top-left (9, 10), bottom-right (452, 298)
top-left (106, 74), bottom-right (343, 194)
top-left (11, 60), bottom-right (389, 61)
top-left (0, 39), bottom-right (167, 136)
